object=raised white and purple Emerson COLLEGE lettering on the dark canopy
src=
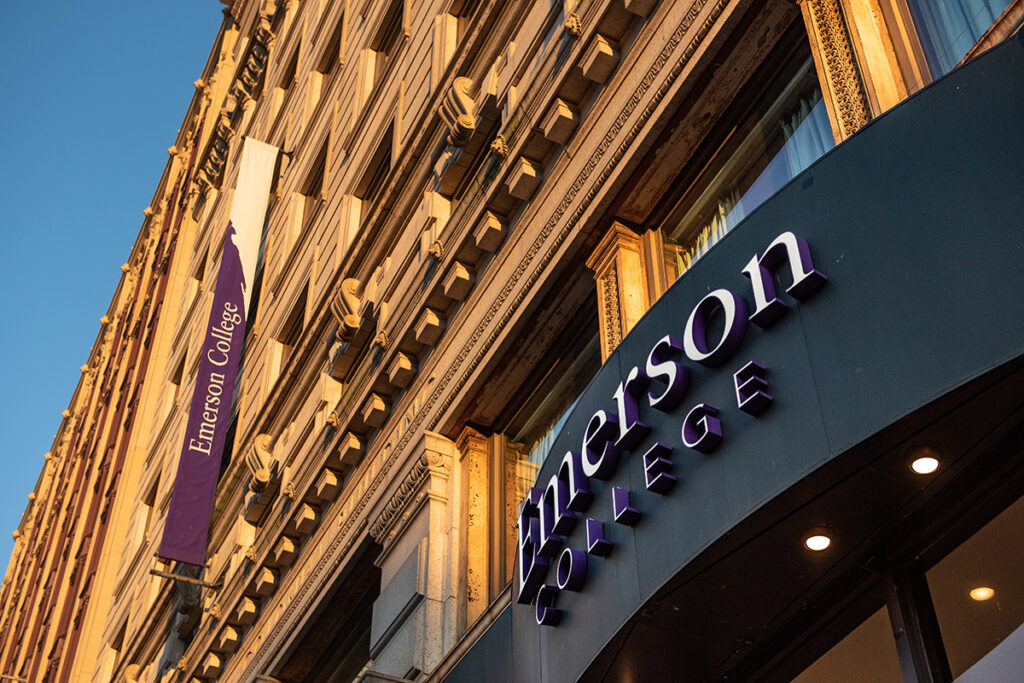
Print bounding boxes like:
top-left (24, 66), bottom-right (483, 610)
top-left (516, 231), bottom-right (827, 626)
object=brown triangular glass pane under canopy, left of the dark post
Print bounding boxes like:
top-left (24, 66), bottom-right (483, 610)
top-left (793, 607), bottom-right (903, 683)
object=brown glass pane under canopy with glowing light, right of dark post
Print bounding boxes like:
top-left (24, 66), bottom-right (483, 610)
top-left (927, 491), bottom-right (1024, 681)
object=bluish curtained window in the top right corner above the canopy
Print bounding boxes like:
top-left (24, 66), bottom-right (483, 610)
top-left (907, 0), bottom-right (1010, 77)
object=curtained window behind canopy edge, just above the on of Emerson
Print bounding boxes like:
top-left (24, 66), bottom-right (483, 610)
top-left (664, 55), bottom-right (835, 276)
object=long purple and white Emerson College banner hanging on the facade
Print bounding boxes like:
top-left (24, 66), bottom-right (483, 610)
top-left (158, 138), bottom-right (278, 566)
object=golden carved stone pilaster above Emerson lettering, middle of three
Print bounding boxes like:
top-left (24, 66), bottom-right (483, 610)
top-left (587, 222), bottom-right (650, 360)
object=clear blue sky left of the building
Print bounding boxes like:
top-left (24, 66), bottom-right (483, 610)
top-left (0, 0), bottom-right (223, 567)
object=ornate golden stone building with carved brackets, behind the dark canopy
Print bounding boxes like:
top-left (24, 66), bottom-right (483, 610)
top-left (0, 0), bottom-right (1024, 683)
